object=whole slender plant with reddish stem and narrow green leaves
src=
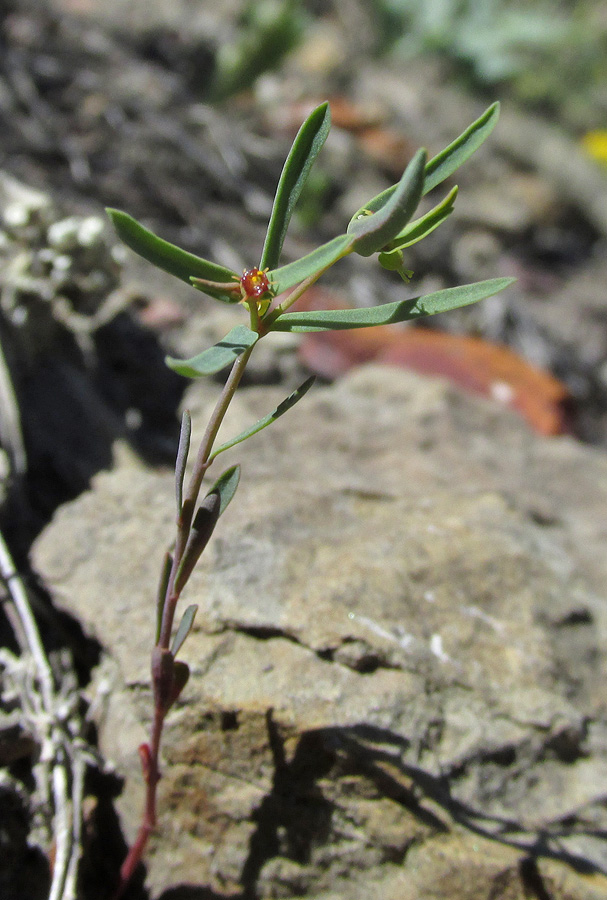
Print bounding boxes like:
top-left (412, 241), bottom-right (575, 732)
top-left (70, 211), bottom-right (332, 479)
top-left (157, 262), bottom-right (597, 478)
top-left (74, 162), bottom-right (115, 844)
top-left (108, 103), bottom-right (513, 898)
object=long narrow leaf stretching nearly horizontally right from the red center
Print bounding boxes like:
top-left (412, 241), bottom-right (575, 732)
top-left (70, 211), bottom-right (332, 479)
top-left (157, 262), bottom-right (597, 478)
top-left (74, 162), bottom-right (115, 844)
top-left (272, 278), bottom-right (516, 331)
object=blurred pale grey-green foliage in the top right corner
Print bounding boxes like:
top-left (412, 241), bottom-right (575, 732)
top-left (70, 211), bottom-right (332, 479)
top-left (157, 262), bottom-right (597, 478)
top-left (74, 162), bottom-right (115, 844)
top-left (374, 0), bottom-right (607, 128)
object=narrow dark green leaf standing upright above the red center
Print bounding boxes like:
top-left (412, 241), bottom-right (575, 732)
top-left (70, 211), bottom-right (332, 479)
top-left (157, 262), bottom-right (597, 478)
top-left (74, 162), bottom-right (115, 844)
top-left (259, 103), bottom-right (331, 269)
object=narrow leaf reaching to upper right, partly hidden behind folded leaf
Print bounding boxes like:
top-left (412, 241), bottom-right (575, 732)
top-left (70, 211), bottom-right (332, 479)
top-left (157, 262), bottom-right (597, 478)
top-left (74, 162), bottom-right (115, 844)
top-left (348, 103), bottom-right (499, 228)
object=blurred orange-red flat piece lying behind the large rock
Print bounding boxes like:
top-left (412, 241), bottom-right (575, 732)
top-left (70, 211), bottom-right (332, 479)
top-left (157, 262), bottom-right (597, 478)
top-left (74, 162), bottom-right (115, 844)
top-left (298, 290), bottom-right (571, 435)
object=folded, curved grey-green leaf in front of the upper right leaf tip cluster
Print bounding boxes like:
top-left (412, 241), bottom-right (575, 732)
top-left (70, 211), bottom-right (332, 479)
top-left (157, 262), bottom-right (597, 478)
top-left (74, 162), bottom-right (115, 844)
top-left (348, 150), bottom-right (426, 256)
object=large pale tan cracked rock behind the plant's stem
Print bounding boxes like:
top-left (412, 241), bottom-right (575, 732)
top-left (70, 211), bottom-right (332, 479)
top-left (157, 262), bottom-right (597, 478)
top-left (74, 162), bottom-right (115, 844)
top-left (33, 367), bottom-right (607, 900)
